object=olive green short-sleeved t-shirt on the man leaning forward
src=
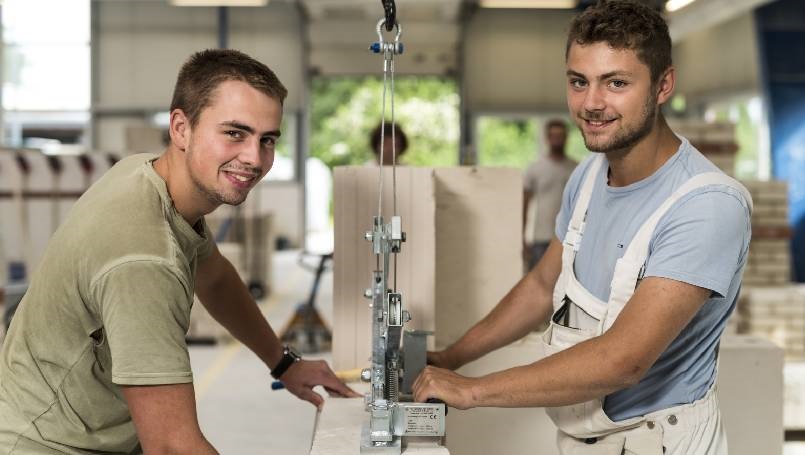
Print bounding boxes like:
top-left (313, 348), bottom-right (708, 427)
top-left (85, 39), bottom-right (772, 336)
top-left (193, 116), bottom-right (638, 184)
top-left (0, 154), bottom-right (214, 455)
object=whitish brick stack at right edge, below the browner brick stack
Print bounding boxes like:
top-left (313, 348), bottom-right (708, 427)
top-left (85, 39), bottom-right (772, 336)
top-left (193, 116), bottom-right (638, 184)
top-left (733, 284), bottom-right (805, 361)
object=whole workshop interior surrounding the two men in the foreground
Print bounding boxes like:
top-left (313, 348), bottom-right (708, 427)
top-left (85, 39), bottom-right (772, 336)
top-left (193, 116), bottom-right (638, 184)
top-left (0, 0), bottom-right (805, 455)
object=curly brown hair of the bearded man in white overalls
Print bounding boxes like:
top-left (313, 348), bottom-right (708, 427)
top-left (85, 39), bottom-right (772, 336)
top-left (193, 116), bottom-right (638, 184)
top-left (565, 0), bottom-right (672, 83)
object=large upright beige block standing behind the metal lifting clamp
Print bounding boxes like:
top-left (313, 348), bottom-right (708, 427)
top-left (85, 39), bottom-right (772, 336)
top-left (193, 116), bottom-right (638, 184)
top-left (333, 166), bottom-right (522, 369)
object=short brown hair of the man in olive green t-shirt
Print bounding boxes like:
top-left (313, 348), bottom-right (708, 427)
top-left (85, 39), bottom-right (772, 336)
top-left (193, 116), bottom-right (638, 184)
top-left (170, 49), bottom-right (288, 126)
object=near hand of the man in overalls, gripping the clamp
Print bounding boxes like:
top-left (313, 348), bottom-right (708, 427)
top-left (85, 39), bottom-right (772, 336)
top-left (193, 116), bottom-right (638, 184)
top-left (414, 366), bottom-right (478, 409)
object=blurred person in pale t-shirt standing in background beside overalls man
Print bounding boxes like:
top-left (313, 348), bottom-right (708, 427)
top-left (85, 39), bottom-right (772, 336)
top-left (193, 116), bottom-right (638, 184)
top-left (523, 119), bottom-right (578, 271)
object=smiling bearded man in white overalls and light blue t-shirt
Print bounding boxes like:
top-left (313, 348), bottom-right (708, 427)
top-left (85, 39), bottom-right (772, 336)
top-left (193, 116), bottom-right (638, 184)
top-left (414, 0), bottom-right (752, 455)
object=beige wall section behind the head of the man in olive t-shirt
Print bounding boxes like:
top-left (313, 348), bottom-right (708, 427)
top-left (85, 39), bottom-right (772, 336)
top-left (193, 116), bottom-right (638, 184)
top-left (92, 0), bottom-right (305, 151)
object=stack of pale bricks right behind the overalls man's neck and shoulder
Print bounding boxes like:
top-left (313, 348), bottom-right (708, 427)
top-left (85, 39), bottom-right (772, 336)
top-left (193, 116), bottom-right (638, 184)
top-left (670, 120), bottom-right (738, 176)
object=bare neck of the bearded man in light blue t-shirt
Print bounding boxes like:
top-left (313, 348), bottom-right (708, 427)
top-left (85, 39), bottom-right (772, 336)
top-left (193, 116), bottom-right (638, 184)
top-left (607, 116), bottom-right (681, 187)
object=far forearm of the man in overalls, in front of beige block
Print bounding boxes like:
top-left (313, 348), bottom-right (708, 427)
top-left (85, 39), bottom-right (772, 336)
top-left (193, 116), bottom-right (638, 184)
top-left (447, 269), bottom-right (552, 368)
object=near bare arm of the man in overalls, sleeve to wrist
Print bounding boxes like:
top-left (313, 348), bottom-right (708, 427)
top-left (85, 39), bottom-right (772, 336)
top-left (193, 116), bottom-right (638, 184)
top-left (472, 277), bottom-right (711, 407)
